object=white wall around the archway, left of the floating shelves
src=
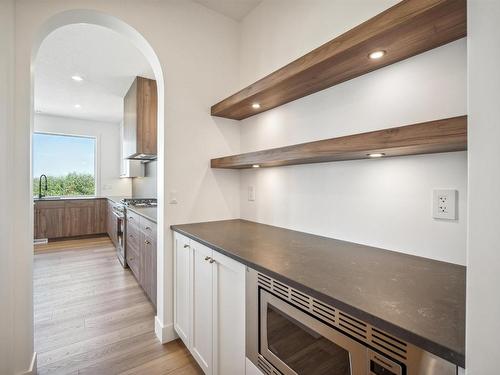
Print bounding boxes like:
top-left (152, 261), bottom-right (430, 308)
top-left (8, 0), bottom-right (239, 374)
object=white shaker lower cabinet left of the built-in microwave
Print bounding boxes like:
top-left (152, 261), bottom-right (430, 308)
top-left (174, 233), bottom-right (245, 375)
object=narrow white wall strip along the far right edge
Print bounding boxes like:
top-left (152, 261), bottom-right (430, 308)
top-left (466, 0), bottom-right (500, 375)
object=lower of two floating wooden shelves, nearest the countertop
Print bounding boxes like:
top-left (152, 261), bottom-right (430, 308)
top-left (210, 116), bottom-right (467, 169)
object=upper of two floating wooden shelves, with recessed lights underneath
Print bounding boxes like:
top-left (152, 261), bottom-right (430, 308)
top-left (211, 0), bottom-right (467, 120)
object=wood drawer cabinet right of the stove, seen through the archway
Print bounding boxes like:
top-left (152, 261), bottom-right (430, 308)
top-left (125, 211), bottom-right (157, 307)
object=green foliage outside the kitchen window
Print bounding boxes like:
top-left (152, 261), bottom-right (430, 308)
top-left (33, 172), bottom-right (95, 197)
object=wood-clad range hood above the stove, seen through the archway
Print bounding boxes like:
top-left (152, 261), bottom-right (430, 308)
top-left (123, 77), bottom-right (158, 160)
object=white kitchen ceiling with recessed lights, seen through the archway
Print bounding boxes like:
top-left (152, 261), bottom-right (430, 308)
top-left (35, 24), bottom-right (154, 122)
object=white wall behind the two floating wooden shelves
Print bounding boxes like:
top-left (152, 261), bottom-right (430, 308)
top-left (240, 0), bottom-right (467, 264)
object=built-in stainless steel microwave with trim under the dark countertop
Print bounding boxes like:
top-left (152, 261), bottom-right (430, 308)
top-left (246, 268), bottom-right (457, 375)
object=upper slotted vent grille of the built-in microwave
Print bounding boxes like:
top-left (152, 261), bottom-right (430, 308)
top-left (257, 272), bottom-right (408, 362)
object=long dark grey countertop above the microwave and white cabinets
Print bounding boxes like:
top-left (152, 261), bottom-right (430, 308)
top-left (171, 220), bottom-right (466, 367)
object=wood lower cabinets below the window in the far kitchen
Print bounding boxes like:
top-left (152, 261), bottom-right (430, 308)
top-left (34, 198), bottom-right (107, 239)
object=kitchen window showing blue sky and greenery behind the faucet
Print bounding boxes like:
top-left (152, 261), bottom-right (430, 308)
top-left (33, 133), bottom-right (97, 197)
